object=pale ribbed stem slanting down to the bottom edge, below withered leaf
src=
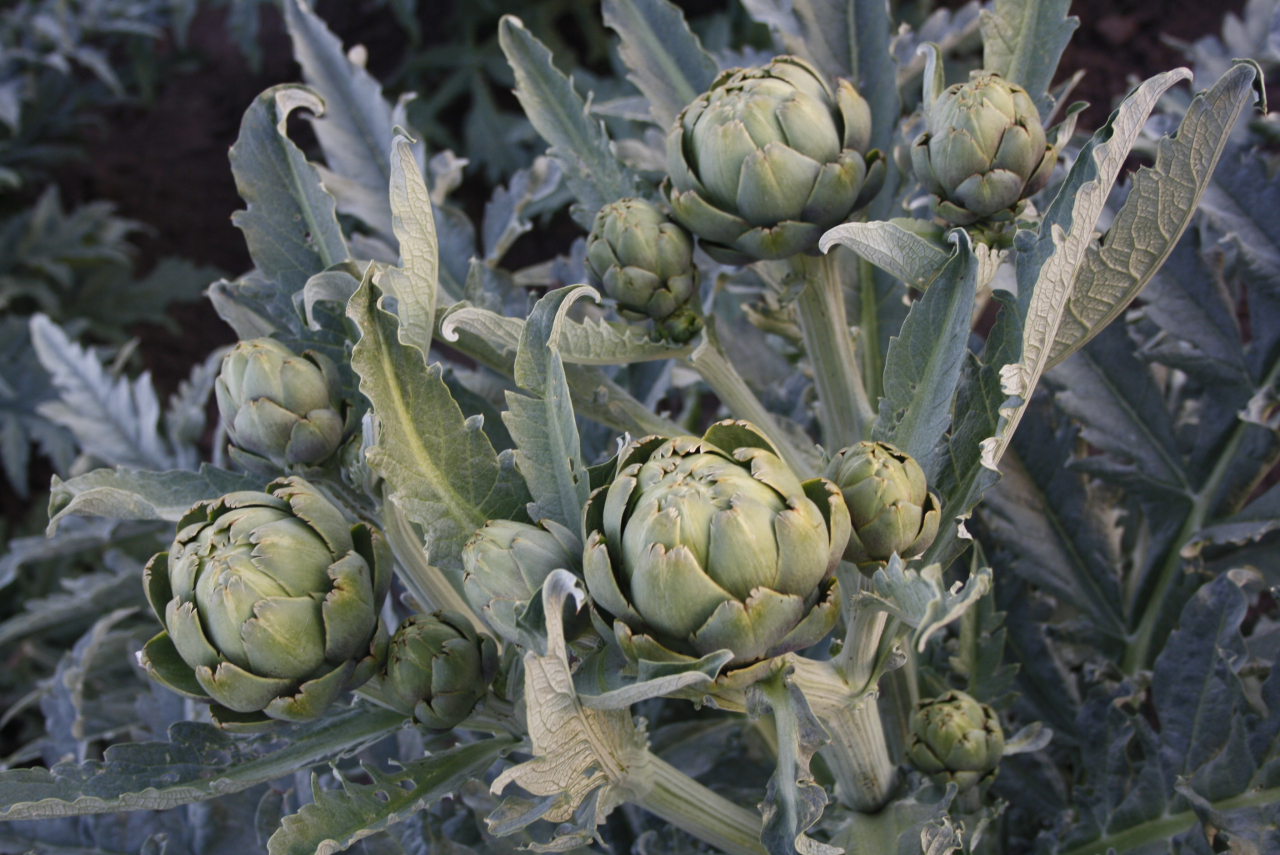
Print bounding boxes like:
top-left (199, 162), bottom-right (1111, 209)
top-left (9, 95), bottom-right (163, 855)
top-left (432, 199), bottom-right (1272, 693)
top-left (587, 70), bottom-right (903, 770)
top-left (626, 751), bottom-right (765, 855)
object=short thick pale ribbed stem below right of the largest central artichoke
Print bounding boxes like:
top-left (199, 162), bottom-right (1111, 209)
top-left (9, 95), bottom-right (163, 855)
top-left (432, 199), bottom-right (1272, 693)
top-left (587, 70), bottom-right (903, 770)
top-left (792, 657), bottom-right (896, 813)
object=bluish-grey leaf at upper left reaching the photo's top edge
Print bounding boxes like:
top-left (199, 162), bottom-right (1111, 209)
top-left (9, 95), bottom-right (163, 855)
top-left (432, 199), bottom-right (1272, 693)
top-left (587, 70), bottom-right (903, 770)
top-left (284, 0), bottom-right (393, 242)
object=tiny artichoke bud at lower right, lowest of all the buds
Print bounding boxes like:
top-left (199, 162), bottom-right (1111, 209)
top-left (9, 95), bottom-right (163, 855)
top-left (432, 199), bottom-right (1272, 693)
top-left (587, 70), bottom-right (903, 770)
top-left (906, 690), bottom-right (1005, 794)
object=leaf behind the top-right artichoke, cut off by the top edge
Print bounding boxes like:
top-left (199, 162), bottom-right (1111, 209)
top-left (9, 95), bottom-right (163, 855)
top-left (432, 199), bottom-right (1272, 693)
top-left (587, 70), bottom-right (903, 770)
top-left (982, 0), bottom-right (1080, 119)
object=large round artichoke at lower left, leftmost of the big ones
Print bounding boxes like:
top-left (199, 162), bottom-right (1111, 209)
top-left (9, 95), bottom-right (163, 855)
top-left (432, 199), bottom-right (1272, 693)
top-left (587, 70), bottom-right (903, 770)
top-left (142, 477), bottom-right (392, 730)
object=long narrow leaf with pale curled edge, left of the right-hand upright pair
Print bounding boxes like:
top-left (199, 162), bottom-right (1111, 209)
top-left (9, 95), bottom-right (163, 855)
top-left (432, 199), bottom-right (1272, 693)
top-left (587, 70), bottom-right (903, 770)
top-left (983, 68), bottom-right (1190, 467)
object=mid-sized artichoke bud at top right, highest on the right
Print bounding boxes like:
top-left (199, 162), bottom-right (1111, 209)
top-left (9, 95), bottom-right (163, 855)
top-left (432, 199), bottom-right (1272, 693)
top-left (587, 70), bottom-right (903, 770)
top-left (911, 72), bottom-right (1057, 225)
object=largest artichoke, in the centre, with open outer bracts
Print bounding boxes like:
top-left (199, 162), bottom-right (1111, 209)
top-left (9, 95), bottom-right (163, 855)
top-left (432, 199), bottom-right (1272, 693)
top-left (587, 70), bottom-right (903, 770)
top-left (582, 421), bottom-right (849, 668)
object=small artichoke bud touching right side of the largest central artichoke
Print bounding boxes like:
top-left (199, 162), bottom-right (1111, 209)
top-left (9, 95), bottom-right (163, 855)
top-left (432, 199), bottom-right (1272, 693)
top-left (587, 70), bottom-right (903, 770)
top-left (827, 442), bottom-right (942, 564)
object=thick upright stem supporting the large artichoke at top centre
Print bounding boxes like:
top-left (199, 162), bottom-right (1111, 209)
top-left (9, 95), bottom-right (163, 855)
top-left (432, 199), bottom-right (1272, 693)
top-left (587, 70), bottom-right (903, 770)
top-left (795, 253), bottom-right (876, 448)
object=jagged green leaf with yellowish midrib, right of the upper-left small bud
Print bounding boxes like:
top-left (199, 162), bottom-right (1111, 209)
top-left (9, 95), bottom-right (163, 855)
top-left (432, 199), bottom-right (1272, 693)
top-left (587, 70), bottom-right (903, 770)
top-left (347, 267), bottom-right (527, 571)
